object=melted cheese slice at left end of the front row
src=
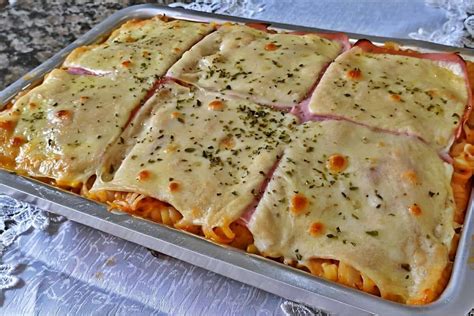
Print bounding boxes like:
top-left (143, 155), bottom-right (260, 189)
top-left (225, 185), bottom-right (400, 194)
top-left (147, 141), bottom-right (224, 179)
top-left (11, 69), bottom-right (150, 185)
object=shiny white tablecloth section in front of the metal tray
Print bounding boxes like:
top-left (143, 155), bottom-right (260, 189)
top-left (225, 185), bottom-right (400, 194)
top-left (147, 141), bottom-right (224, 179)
top-left (0, 221), bottom-right (282, 315)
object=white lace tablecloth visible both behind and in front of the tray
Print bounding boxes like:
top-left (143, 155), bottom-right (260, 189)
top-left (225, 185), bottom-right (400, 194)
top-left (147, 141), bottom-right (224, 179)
top-left (0, 0), bottom-right (466, 315)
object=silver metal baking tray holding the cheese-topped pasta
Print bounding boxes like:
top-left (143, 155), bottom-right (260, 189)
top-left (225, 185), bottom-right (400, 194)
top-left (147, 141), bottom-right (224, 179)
top-left (0, 4), bottom-right (474, 315)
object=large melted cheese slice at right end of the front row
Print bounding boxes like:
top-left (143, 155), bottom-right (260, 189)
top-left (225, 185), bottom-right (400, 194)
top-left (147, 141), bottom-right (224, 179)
top-left (248, 121), bottom-right (454, 302)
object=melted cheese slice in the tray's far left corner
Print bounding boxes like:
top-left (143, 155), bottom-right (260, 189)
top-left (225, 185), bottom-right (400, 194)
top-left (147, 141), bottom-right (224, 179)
top-left (64, 17), bottom-right (213, 79)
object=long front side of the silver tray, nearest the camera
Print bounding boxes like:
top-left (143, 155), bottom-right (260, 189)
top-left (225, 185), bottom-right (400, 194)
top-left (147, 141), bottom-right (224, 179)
top-left (0, 170), bottom-right (474, 315)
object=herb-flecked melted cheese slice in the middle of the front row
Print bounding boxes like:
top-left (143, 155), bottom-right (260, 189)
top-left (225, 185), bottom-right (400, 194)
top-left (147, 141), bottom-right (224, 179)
top-left (91, 82), bottom-right (297, 229)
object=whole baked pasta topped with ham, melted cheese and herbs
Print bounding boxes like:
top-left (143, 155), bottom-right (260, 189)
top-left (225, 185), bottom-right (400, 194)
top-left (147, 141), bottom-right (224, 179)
top-left (0, 16), bottom-right (474, 304)
